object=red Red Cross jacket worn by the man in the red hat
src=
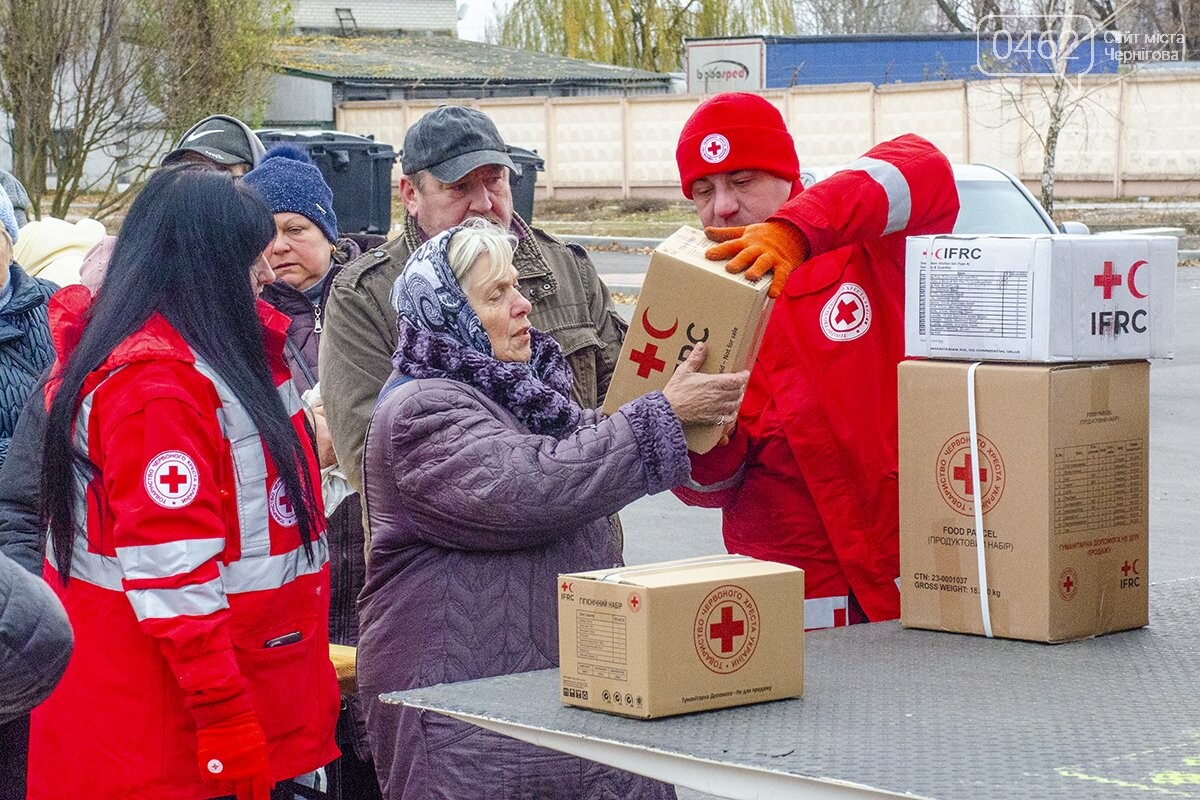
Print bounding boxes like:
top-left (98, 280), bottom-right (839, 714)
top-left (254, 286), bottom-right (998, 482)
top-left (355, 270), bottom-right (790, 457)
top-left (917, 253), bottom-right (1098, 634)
top-left (676, 134), bottom-right (959, 628)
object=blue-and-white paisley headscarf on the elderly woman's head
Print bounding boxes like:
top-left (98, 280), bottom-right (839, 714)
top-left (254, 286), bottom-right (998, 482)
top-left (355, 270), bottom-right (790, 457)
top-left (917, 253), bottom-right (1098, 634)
top-left (391, 225), bottom-right (493, 355)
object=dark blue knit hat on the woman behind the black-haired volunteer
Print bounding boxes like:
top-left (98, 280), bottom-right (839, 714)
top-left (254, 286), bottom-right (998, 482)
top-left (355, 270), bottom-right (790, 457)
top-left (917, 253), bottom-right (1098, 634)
top-left (241, 144), bottom-right (337, 242)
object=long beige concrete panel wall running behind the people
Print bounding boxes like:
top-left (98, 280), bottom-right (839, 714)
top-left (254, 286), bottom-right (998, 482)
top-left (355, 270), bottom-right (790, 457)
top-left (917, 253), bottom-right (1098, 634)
top-left (336, 72), bottom-right (1200, 198)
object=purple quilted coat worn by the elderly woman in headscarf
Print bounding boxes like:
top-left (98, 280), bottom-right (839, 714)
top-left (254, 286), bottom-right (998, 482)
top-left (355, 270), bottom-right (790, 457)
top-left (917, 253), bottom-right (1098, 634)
top-left (358, 333), bottom-right (689, 800)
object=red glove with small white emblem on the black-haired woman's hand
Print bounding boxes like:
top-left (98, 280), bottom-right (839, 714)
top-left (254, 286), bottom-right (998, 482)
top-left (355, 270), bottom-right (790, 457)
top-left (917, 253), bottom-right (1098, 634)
top-left (196, 711), bottom-right (274, 800)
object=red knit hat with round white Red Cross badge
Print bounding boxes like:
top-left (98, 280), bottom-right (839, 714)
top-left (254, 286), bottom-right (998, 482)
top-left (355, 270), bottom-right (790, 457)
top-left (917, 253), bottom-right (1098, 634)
top-left (676, 91), bottom-right (800, 200)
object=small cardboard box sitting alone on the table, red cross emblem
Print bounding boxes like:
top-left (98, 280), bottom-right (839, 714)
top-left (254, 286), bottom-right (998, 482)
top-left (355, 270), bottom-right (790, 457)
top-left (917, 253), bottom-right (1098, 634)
top-left (558, 555), bottom-right (804, 718)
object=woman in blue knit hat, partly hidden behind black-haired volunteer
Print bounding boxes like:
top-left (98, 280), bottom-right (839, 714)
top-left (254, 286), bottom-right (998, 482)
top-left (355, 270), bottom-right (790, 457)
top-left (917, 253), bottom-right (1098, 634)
top-left (242, 145), bottom-right (379, 800)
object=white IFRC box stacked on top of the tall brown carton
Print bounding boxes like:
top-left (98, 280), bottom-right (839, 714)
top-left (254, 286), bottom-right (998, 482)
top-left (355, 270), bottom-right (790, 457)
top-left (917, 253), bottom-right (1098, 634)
top-left (905, 234), bottom-right (1178, 362)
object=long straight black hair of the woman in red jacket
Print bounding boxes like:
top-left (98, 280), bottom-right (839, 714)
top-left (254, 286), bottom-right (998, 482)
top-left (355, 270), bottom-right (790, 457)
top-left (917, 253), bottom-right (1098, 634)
top-left (41, 164), bottom-right (319, 583)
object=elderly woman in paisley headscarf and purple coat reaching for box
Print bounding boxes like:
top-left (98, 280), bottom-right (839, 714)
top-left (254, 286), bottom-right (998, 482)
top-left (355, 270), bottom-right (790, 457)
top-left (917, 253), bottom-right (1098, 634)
top-left (358, 221), bottom-right (746, 800)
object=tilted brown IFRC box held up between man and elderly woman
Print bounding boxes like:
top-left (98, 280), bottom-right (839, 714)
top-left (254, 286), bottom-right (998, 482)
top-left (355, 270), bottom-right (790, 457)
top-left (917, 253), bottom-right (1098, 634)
top-left (604, 227), bottom-right (774, 453)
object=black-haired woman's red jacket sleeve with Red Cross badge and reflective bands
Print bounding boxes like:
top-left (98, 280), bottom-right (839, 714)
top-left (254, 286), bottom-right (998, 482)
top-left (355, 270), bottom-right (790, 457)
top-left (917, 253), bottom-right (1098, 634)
top-left (103, 386), bottom-right (253, 727)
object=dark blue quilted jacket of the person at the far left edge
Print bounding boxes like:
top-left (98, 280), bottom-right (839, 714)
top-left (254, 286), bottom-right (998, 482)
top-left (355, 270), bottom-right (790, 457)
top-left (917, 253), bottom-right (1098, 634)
top-left (0, 261), bottom-right (59, 464)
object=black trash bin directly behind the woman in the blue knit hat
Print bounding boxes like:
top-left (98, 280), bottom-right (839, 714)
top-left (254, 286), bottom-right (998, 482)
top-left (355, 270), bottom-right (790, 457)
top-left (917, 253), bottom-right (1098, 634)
top-left (256, 131), bottom-right (396, 236)
